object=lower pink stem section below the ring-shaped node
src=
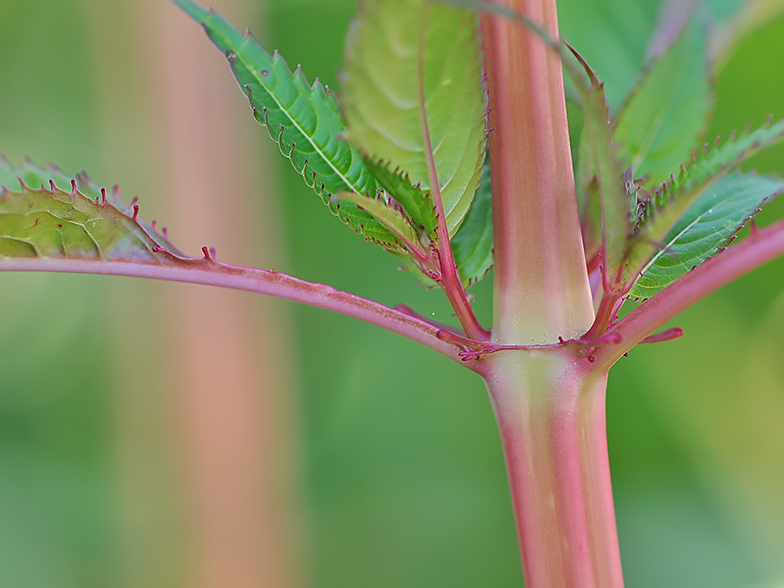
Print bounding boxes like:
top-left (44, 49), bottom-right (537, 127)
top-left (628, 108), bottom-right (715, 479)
top-left (485, 351), bottom-right (623, 588)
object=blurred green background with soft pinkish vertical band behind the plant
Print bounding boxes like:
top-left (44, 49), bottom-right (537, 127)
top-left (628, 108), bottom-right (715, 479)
top-left (0, 0), bottom-right (784, 588)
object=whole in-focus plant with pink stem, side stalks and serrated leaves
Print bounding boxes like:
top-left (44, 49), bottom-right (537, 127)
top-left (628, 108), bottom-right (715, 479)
top-left (0, 0), bottom-right (784, 588)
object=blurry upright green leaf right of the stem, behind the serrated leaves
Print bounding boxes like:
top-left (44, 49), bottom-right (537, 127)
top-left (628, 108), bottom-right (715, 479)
top-left (614, 23), bottom-right (713, 186)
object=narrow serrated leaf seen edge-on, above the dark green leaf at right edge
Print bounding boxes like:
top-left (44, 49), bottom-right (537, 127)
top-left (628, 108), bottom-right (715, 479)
top-left (628, 120), bottom-right (784, 275)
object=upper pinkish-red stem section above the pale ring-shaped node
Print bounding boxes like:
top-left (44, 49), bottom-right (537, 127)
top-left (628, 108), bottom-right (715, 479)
top-left (482, 0), bottom-right (593, 345)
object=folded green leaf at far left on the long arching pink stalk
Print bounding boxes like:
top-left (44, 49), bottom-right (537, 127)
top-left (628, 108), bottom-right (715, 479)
top-left (0, 158), bottom-right (181, 264)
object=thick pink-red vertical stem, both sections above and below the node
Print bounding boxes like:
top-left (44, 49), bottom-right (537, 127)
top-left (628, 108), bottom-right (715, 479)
top-left (480, 0), bottom-right (623, 588)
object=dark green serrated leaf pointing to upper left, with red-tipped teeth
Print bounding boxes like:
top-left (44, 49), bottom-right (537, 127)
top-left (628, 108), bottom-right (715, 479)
top-left (174, 0), bottom-right (398, 249)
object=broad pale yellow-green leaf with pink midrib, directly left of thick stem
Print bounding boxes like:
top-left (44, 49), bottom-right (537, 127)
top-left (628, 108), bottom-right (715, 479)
top-left (342, 0), bottom-right (486, 235)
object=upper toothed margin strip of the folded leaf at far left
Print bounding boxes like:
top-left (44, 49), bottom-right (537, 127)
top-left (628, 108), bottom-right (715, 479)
top-left (0, 156), bottom-right (182, 256)
